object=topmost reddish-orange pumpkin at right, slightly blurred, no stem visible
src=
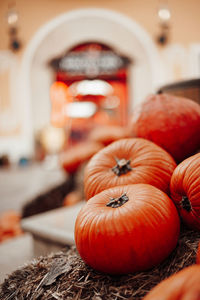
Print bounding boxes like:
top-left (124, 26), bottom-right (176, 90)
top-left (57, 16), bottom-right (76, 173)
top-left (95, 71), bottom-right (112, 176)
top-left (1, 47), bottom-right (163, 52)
top-left (130, 94), bottom-right (200, 162)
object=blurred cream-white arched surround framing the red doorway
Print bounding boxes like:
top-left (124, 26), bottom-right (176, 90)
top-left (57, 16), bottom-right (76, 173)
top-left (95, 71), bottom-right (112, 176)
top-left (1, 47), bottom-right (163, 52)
top-left (20, 9), bottom-right (162, 156)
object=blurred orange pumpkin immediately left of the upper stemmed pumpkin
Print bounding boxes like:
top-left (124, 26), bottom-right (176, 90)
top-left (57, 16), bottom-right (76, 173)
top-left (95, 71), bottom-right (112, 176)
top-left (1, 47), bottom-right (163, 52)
top-left (59, 141), bottom-right (103, 174)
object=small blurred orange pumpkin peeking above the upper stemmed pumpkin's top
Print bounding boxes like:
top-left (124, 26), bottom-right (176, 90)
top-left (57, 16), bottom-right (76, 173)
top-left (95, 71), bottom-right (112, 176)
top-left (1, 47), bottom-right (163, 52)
top-left (88, 125), bottom-right (129, 146)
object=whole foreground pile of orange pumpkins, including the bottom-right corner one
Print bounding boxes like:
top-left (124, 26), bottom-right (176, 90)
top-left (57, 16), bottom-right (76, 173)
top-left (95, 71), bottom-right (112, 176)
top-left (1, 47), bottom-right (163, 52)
top-left (75, 94), bottom-right (200, 300)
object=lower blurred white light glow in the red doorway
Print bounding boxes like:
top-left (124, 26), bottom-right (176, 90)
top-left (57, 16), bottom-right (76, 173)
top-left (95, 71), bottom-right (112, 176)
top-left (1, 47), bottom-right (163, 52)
top-left (65, 101), bottom-right (97, 118)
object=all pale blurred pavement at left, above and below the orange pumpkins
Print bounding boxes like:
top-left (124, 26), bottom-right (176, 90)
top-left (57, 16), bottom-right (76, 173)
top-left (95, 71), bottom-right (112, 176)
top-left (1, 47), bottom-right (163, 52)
top-left (0, 164), bottom-right (66, 282)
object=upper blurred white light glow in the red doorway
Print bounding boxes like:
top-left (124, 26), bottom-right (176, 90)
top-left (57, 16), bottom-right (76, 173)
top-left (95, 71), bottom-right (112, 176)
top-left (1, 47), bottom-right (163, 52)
top-left (70, 79), bottom-right (113, 96)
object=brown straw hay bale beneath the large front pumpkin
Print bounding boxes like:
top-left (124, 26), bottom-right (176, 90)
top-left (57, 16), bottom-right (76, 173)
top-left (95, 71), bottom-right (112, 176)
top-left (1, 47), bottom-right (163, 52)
top-left (0, 228), bottom-right (200, 300)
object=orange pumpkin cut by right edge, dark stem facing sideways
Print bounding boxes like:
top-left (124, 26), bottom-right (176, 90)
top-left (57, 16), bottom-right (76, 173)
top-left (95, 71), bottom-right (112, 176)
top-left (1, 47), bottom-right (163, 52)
top-left (170, 153), bottom-right (200, 230)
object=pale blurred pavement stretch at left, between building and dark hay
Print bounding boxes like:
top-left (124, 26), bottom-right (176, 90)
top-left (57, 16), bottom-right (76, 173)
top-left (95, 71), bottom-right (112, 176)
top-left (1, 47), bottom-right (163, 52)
top-left (0, 164), bottom-right (66, 213)
